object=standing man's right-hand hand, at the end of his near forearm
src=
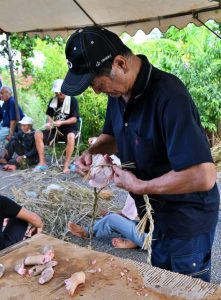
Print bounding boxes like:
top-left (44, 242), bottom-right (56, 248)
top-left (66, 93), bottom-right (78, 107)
top-left (113, 166), bottom-right (142, 194)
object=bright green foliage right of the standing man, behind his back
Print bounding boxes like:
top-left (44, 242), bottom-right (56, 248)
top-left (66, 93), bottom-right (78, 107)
top-left (128, 21), bottom-right (221, 132)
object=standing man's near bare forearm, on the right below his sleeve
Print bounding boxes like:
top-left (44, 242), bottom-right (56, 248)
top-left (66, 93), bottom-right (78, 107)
top-left (133, 163), bottom-right (216, 195)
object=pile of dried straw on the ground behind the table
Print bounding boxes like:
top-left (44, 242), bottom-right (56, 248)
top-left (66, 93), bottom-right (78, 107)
top-left (11, 169), bottom-right (121, 240)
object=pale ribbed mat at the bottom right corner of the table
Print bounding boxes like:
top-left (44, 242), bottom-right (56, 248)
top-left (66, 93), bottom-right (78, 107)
top-left (128, 259), bottom-right (218, 300)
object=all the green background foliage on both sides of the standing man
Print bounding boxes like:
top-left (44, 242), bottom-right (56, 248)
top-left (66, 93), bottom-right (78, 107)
top-left (0, 21), bottom-right (221, 143)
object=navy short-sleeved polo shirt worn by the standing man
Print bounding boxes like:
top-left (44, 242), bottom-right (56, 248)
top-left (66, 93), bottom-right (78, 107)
top-left (103, 56), bottom-right (219, 239)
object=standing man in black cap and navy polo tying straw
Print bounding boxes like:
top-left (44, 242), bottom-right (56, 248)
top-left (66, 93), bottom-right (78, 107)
top-left (62, 27), bottom-right (219, 281)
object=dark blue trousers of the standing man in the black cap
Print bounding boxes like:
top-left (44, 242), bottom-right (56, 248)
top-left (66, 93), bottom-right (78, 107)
top-left (152, 226), bottom-right (215, 282)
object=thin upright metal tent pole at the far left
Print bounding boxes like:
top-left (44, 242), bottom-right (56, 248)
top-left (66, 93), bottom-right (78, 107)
top-left (6, 32), bottom-right (20, 121)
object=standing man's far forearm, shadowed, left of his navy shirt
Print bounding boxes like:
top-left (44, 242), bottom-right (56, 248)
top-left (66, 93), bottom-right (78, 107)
top-left (86, 134), bottom-right (117, 155)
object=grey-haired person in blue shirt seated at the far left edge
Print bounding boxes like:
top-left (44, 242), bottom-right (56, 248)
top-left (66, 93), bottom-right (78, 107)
top-left (0, 86), bottom-right (24, 142)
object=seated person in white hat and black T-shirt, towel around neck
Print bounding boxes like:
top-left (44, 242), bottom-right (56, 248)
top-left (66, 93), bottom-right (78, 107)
top-left (34, 79), bottom-right (79, 173)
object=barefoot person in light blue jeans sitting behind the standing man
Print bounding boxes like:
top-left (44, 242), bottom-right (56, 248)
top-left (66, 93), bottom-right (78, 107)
top-left (68, 194), bottom-right (146, 249)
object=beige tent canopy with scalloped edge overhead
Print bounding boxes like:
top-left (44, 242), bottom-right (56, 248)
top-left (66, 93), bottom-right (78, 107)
top-left (0, 0), bottom-right (221, 37)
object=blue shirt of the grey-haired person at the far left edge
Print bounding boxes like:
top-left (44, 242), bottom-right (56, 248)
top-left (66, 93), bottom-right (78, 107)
top-left (2, 97), bottom-right (24, 127)
